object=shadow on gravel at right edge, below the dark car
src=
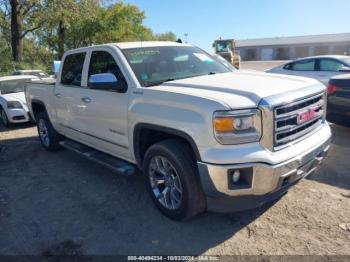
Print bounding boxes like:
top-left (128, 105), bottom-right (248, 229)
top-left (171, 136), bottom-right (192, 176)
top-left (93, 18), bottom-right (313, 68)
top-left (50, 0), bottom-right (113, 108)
top-left (308, 124), bottom-right (350, 189)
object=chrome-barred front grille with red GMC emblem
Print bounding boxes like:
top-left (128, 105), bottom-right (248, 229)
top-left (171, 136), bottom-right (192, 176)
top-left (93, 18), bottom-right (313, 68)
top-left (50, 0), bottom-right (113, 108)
top-left (274, 94), bottom-right (325, 148)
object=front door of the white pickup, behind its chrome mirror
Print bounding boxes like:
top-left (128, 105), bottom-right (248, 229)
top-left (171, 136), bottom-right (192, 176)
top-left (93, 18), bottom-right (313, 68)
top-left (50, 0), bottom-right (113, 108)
top-left (72, 48), bottom-right (130, 159)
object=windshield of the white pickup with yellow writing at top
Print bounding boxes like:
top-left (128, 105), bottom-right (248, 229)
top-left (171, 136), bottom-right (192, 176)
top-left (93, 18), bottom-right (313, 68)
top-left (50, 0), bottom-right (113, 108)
top-left (123, 46), bottom-right (231, 86)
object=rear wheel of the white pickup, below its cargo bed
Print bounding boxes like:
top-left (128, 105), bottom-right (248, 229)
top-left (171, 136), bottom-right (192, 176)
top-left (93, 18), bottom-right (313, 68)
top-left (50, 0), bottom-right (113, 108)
top-left (35, 112), bottom-right (61, 152)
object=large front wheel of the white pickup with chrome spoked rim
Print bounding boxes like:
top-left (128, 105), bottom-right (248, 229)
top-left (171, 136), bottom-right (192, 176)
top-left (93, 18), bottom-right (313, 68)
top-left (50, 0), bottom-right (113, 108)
top-left (143, 139), bottom-right (206, 221)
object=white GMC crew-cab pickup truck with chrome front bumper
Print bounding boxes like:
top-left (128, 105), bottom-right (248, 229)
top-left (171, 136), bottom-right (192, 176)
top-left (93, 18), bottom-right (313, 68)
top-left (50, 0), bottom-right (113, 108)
top-left (26, 42), bottom-right (331, 220)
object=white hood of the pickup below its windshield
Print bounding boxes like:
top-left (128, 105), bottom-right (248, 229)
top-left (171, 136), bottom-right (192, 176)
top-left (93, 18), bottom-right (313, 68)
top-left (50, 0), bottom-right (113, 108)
top-left (150, 70), bottom-right (321, 109)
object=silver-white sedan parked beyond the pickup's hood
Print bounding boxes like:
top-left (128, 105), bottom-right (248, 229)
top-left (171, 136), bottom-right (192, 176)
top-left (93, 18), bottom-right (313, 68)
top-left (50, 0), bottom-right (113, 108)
top-left (267, 55), bottom-right (350, 85)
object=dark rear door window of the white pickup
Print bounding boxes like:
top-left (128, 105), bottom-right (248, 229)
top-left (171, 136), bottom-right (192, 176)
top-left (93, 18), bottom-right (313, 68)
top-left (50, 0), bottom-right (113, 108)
top-left (61, 53), bottom-right (85, 86)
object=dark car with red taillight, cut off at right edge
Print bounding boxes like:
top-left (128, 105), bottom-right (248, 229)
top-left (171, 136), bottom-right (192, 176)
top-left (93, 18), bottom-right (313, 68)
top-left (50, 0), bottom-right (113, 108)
top-left (328, 74), bottom-right (350, 122)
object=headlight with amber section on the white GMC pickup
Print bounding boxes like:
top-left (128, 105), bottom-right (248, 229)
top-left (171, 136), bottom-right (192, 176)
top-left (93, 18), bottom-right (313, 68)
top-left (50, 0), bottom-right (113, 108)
top-left (213, 109), bottom-right (261, 145)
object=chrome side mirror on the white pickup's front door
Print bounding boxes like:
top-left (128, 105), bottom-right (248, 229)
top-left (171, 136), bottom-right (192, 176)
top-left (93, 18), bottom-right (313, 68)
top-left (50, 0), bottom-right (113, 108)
top-left (88, 73), bottom-right (126, 93)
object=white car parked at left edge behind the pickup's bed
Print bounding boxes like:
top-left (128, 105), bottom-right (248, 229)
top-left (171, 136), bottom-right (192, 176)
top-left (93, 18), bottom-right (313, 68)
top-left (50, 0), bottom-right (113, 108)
top-left (0, 75), bottom-right (39, 126)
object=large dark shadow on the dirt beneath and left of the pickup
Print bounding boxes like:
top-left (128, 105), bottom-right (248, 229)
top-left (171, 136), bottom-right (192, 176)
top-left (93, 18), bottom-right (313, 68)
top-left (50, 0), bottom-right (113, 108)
top-left (0, 138), bottom-right (275, 255)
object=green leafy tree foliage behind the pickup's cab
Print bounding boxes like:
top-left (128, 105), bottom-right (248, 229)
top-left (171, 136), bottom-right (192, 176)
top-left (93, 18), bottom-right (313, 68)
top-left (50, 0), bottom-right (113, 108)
top-left (0, 0), bottom-right (176, 75)
